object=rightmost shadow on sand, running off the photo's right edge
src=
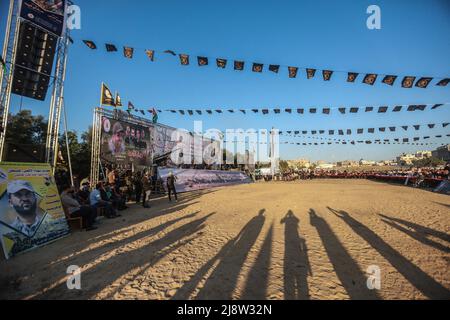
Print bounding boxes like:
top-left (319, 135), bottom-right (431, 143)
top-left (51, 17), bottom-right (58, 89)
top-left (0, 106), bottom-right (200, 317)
top-left (379, 214), bottom-right (450, 252)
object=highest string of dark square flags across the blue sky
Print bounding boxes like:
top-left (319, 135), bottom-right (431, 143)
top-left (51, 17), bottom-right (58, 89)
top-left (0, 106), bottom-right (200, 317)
top-left (83, 40), bottom-right (450, 89)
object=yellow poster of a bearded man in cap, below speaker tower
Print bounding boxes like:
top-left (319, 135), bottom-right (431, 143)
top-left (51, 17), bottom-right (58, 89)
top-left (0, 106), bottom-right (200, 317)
top-left (0, 162), bottom-right (69, 259)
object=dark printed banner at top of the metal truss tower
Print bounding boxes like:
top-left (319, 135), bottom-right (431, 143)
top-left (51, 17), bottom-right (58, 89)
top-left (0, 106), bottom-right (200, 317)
top-left (20, 0), bottom-right (66, 37)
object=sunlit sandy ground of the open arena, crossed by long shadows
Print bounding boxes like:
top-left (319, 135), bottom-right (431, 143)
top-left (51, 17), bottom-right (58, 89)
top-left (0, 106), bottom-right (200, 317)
top-left (0, 180), bottom-right (450, 299)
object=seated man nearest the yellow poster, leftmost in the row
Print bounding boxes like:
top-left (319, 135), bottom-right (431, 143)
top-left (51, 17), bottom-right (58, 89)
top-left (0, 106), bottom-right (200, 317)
top-left (61, 185), bottom-right (97, 231)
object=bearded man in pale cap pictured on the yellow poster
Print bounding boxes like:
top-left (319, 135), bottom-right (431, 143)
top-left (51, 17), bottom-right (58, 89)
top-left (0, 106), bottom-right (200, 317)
top-left (7, 180), bottom-right (42, 237)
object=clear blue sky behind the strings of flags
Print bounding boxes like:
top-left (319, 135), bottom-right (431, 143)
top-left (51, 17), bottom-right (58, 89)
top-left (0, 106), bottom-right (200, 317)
top-left (0, 0), bottom-right (450, 161)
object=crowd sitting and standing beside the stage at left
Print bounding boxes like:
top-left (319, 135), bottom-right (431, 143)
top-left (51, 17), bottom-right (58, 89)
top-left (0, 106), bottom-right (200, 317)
top-left (56, 167), bottom-right (178, 231)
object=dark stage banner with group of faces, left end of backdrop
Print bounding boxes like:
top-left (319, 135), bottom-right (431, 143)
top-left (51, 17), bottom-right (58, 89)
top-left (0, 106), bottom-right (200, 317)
top-left (100, 117), bottom-right (152, 166)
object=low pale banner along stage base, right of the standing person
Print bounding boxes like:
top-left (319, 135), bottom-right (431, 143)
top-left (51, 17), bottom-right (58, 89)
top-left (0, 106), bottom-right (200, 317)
top-left (158, 168), bottom-right (252, 192)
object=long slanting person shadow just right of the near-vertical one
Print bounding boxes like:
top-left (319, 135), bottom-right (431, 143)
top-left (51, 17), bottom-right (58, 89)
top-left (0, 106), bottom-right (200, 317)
top-left (309, 209), bottom-right (379, 300)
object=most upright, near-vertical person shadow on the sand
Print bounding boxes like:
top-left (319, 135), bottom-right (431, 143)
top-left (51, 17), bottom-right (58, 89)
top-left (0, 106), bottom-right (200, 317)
top-left (280, 210), bottom-right (312, 300)
